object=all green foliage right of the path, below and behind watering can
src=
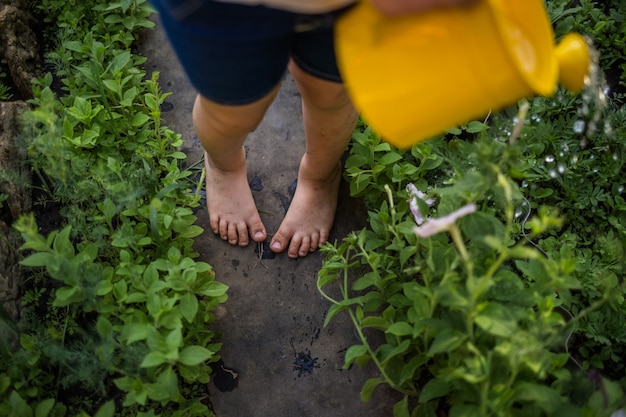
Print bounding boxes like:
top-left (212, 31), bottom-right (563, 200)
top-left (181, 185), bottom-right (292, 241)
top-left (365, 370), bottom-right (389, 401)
top-left (318, 0), bottom-right (626, 417)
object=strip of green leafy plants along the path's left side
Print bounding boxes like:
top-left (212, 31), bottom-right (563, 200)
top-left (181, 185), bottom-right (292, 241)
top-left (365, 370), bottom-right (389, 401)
top-left (0, 0), bottom-right (227, 417)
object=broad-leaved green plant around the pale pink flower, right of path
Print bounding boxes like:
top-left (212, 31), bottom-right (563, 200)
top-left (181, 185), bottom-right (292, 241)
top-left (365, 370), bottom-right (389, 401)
top-left (318, 106), bottom-right (623, 416)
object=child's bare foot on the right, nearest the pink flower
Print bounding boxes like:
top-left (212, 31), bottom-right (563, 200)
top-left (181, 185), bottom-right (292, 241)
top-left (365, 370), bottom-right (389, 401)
top-left (270, 159), bottom-right (341, 258)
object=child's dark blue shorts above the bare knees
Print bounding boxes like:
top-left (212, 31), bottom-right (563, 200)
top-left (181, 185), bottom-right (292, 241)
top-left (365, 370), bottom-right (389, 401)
top-left (147, 0), bottom-right (347, 105)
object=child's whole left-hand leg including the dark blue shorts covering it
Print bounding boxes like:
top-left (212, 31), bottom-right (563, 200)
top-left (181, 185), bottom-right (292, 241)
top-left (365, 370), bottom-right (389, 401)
top-left (152, 0), bottom-right (293, 246)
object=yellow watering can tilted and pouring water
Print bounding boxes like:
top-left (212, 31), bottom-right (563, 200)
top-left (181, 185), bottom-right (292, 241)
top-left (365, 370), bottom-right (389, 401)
top-left (336, 0), bottom-right (590, 147)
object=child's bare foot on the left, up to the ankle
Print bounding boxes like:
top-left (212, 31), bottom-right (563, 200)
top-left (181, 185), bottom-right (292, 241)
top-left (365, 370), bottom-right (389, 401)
top-left (204, 148), bottom-right (267, 246)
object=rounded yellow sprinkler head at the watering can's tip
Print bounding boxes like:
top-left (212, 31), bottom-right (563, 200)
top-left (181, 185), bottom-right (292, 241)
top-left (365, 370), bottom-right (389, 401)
top-left (555, 33), bottom-right (591, 93)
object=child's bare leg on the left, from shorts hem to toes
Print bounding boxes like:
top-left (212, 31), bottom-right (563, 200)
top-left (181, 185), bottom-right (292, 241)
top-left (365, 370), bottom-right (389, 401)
top-left (193, 87), bottom-right (278, 246)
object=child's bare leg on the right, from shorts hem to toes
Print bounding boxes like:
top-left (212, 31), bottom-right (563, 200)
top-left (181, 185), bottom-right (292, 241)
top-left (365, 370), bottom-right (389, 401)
top-left (270, 61), bottom-right (358, 258)
